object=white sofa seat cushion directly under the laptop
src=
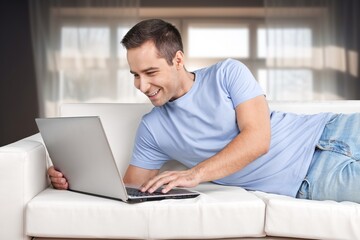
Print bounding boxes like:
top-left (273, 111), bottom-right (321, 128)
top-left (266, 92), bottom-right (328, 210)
top-left (25, 183), bottom-right (265, 239)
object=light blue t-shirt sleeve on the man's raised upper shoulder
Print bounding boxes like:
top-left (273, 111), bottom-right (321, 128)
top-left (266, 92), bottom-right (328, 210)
top-left (223, 59), bottom-right (264, 108)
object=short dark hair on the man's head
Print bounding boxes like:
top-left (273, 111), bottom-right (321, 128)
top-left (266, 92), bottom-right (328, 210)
top-left (121, 19), bottom-right (184, 65)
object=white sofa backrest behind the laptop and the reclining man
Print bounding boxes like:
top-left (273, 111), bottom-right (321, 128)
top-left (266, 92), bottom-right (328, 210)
top-left (60, 101), bottom-right (360, 174)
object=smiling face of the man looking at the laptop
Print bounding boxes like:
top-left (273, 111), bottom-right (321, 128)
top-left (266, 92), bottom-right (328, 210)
top-left (127, 41), bottom-right (184, 106)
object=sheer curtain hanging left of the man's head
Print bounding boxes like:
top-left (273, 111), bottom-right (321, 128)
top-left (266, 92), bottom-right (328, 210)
top-left (29, 0), bottom-right (141, 116)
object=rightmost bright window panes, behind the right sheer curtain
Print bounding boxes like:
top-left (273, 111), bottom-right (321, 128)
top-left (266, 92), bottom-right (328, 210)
top-left (257, 27), bottom-right (314, 101)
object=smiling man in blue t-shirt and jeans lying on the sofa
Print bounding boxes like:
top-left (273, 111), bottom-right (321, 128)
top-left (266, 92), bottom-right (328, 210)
top-left (48, 19), bottom-right (360, 202)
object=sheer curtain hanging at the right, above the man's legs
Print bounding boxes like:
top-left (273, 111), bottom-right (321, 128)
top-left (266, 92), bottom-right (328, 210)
top-left (259, 0), bottom-right (360, 101)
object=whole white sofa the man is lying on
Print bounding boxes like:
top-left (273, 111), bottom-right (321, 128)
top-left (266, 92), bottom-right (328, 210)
top-left (0, 101), bottom-right (360, 240)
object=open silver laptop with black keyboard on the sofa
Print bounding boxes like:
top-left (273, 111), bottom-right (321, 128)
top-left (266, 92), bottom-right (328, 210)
top-left (35, 116), bottom-right (199, 203)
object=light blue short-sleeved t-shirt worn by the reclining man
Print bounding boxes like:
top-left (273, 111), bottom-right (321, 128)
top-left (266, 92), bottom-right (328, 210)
top-left (130, 59), bottom-right (330, 196)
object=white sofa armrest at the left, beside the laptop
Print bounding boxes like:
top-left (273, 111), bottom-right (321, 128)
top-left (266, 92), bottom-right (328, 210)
top-left (0, 134), bottom-right (48, 240)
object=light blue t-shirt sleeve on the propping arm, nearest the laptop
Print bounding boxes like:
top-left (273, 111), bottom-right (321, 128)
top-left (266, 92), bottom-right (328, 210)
top-left (130, 120), bottom-right (169, 169)
